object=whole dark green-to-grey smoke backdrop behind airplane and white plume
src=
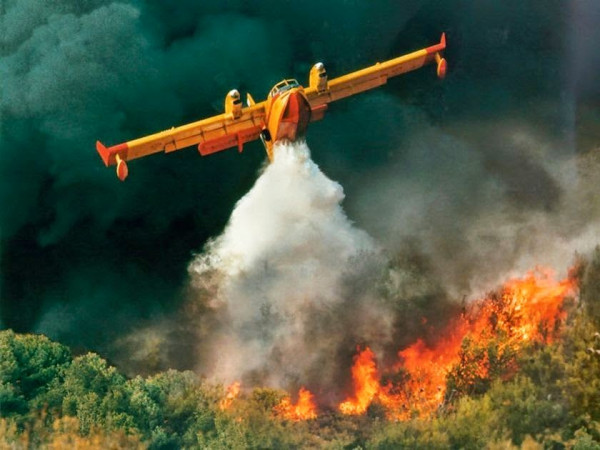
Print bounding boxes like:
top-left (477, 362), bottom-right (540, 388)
top-left (0, 0), bottom-right (600, 386)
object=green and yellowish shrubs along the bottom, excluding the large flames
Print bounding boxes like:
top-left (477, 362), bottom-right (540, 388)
top-left (0, 251), bottom-right (600, 449)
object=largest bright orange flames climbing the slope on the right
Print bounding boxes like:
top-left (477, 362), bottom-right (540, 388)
top-left (339, 269), bottom-right (575, 420)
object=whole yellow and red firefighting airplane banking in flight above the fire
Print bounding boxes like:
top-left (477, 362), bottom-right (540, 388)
top-left (96, 34), bottom-right (447, 181)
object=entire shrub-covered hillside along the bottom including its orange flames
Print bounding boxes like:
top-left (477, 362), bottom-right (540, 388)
top-left (0, 258), bottom-right (600, 448)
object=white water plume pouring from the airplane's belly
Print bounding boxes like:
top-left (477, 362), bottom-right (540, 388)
top-left (189, 143), bottom-right (392, 387)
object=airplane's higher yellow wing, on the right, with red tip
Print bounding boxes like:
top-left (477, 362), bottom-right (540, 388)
top-left (305, 33), bottom-right (447, 121)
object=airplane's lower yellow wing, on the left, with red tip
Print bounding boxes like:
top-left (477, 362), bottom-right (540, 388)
top-left (96, 102), bottom-right (266, 181)
